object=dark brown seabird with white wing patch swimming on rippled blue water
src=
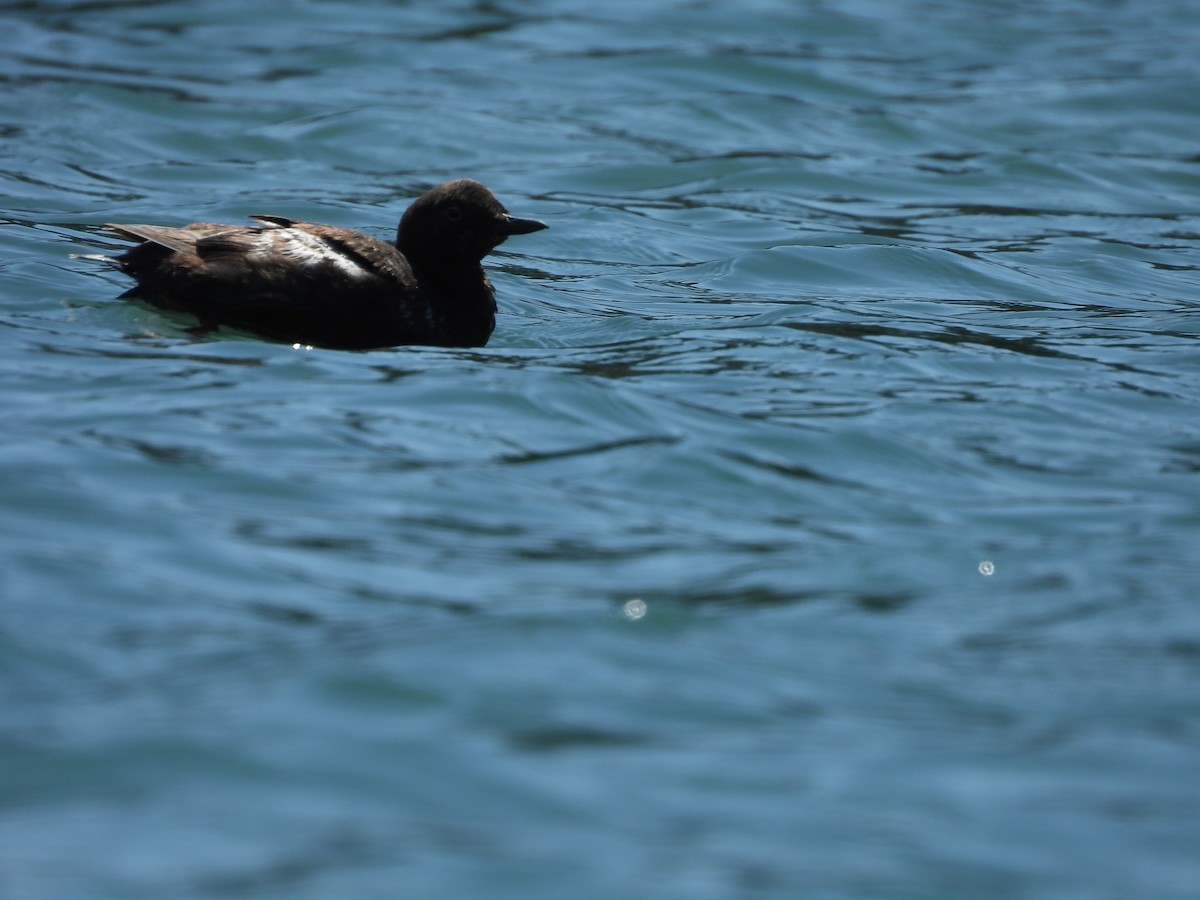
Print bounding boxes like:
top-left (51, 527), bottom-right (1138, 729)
top-left (99, 179), bottom-right (547, 349)
